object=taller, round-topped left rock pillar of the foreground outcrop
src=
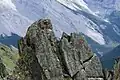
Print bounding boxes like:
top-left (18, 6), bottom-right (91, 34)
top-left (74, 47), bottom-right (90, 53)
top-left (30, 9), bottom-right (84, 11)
top-left (19, 20), bottom-right (63, 80)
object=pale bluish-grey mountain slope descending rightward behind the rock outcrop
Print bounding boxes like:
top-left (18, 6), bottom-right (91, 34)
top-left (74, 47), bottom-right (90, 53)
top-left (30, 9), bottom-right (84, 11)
top-left (0, 0), bottom-right (105, 44)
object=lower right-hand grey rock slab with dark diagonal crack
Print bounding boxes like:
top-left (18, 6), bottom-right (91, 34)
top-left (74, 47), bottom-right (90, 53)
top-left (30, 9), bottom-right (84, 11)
top-left (58, 33), bottom-right (103, 80)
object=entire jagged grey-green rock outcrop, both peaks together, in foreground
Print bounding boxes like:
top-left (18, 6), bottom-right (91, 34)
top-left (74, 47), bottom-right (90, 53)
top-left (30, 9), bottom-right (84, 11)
top-left (19, 19), bottom-right (104, 80)
